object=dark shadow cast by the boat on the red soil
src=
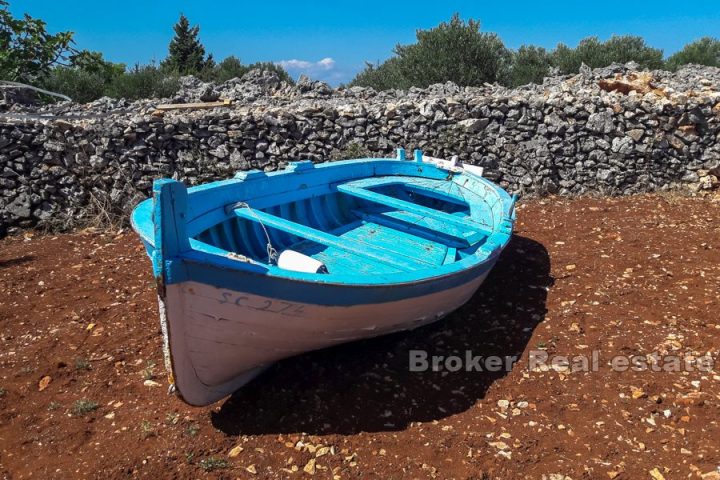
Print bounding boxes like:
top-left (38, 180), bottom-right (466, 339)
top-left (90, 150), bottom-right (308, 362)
top-left (211, 235), bottom-right (553, 435)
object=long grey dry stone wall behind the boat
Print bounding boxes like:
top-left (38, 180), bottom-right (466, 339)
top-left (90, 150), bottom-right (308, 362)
top-left (0, 64), bottom-right (720, 234)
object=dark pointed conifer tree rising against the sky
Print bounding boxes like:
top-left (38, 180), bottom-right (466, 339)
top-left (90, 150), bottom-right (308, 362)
top-left (161, 14), bottom-right (215, 75)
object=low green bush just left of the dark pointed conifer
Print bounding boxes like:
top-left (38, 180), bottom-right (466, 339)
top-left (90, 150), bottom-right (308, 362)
top-left (106, 65), bottom-right (180, 100)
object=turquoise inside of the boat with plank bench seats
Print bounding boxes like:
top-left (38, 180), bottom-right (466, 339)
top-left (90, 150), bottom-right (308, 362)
top-left (191, 175), bottom-right (499, 275)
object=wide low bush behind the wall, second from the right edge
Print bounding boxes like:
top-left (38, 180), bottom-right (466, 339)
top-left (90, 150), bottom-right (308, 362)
top-left (552, 35), bottom-right (663, 74)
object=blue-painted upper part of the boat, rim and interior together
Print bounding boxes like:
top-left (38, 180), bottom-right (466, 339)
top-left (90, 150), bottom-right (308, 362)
top-left (132, 151), bottom-right (515, 288)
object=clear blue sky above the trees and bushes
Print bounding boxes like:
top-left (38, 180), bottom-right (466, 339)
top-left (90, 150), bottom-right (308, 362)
top-left (11, 0), bottom-right (720, 85)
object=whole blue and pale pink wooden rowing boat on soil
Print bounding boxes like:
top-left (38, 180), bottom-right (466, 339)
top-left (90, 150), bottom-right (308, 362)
top-left (132, 149), bottom-right (515, 405)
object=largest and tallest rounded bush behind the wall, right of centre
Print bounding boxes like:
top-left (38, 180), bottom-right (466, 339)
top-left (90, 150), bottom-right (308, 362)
top-left (351, 14), bottom-right (511, 90)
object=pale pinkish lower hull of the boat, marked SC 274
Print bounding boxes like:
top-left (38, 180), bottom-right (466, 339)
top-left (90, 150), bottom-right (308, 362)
top-left (160, 262), bottom-right (494, 406)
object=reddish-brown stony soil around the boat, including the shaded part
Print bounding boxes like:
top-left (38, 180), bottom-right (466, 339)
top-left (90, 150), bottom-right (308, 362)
top-left (0, 195), bottom-right (720, 480)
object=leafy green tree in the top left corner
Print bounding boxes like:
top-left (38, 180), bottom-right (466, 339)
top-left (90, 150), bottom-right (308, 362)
top-left (0, 0), bottom-right (74, 82)
